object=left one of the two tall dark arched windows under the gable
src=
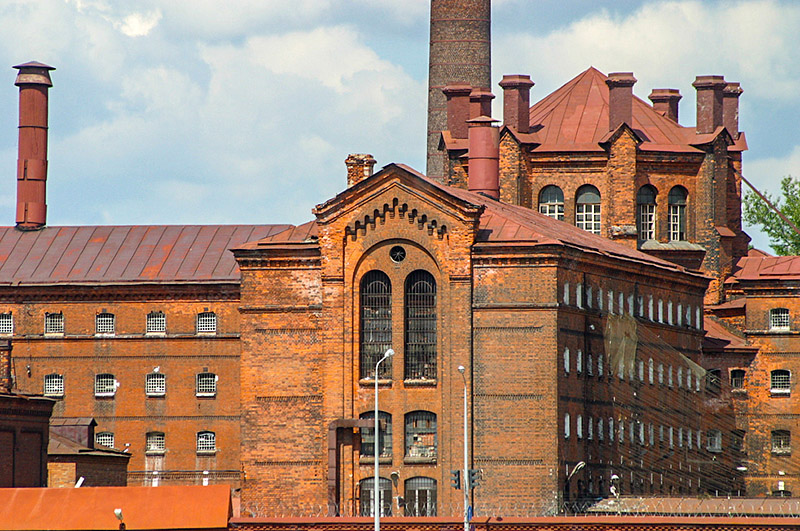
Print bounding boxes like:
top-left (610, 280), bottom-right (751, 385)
top-left (360, 271), bottom-right (392, 379)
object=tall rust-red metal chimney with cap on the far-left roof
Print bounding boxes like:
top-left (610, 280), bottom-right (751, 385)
top-left (14, 62), bottom-right (55, 230)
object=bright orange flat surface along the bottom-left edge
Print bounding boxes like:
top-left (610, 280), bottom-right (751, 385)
top-left (0, 485), bottom-right (231, 531)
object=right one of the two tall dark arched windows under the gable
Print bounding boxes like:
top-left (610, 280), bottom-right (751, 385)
top-left (404, 271), bottom-right (436, 380)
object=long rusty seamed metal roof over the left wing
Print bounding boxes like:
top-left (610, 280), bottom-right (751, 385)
top-left (0, 225), bottom-right (291, 285)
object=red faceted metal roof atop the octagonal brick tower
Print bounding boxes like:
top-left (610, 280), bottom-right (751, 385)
top-left (530, 67), bottom-right (744, 152)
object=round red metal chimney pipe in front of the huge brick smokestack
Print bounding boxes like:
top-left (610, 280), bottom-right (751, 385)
top-left (467, 116), bottom-right (500, 199)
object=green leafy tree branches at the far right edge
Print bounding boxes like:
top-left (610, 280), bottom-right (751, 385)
top-left (742, 175), bottom-right (800, 255)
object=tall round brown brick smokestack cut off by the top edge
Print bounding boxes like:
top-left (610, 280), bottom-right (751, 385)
top-left (426, 0), bottom-right (492, 180)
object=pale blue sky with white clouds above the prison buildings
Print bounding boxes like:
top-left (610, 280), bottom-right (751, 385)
top-left (0, 0), bottom-right (800, 251)
